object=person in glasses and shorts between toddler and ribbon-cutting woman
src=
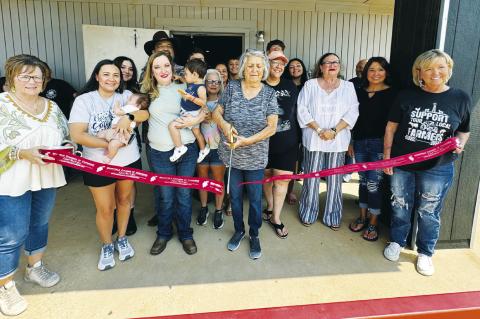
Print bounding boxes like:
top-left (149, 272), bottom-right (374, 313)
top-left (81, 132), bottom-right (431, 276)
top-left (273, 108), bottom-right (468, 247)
top-left (197, 69), bottom-right (225, 229)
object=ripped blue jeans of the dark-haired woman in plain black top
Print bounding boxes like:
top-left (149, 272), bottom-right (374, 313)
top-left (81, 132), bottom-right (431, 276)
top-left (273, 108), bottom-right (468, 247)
top-left (353, 138), bottom-right (383, 215)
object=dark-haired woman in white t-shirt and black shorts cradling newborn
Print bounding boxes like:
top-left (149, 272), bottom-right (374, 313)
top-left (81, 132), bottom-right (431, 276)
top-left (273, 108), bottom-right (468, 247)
top-left (69, 60), bottom-right (149, 270)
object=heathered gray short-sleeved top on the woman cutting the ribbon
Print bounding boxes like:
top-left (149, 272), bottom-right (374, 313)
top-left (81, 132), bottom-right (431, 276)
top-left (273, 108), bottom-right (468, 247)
top-left (218, 81), bottom-right (279, 170)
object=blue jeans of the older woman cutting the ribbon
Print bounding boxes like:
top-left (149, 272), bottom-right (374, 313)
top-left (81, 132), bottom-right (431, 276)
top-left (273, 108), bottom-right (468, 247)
top-left (225, 167), bottom-right (264, 237)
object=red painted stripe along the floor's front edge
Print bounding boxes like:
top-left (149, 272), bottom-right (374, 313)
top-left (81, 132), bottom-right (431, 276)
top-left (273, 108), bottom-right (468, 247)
top-left (138, 291), bottom-right (480, 319)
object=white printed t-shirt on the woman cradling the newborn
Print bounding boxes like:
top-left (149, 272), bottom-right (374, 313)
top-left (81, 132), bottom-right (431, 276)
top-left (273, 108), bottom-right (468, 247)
top-left (68, 90), bottom-right (140, 166)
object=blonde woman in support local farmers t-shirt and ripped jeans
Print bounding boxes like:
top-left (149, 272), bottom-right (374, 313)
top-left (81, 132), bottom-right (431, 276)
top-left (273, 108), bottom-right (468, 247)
top-left (383, 50), bottom-right (471, 276)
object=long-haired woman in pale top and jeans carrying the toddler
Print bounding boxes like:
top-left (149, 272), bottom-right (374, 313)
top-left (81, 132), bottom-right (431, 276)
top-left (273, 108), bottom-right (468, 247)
top-left (141, 52), bottom-right (205, 255)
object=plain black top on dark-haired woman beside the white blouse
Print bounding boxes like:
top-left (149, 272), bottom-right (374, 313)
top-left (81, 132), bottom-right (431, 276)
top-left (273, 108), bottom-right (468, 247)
top-left (352, 87), bottom-right (398, 140)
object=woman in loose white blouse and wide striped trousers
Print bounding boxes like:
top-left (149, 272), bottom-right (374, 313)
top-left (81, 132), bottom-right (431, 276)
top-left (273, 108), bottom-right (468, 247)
top-left (297, 53), bottom-right (358, 230)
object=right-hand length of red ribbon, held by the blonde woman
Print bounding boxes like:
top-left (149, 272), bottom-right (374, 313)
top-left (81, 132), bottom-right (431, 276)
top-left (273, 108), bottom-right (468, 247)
top-left (241, 137), bottom-right (458, 184)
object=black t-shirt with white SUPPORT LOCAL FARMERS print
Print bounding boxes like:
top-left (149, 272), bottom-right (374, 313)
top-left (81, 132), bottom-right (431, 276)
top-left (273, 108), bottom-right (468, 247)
top-left (388, 88), bottom-right (471, 170)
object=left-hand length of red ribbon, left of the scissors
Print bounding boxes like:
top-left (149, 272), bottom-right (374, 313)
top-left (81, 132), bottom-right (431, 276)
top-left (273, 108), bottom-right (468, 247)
top-left (40, 149), bottom-right (223, 194)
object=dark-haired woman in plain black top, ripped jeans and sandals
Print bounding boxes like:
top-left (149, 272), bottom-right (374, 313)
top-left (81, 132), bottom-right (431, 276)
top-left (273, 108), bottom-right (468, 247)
top-left (348, 57), bottom-right (397, 241)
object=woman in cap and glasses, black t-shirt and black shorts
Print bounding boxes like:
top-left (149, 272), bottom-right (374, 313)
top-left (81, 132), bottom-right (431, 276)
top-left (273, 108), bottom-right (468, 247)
top-left (263, 51), bottom-right (299, 238)
